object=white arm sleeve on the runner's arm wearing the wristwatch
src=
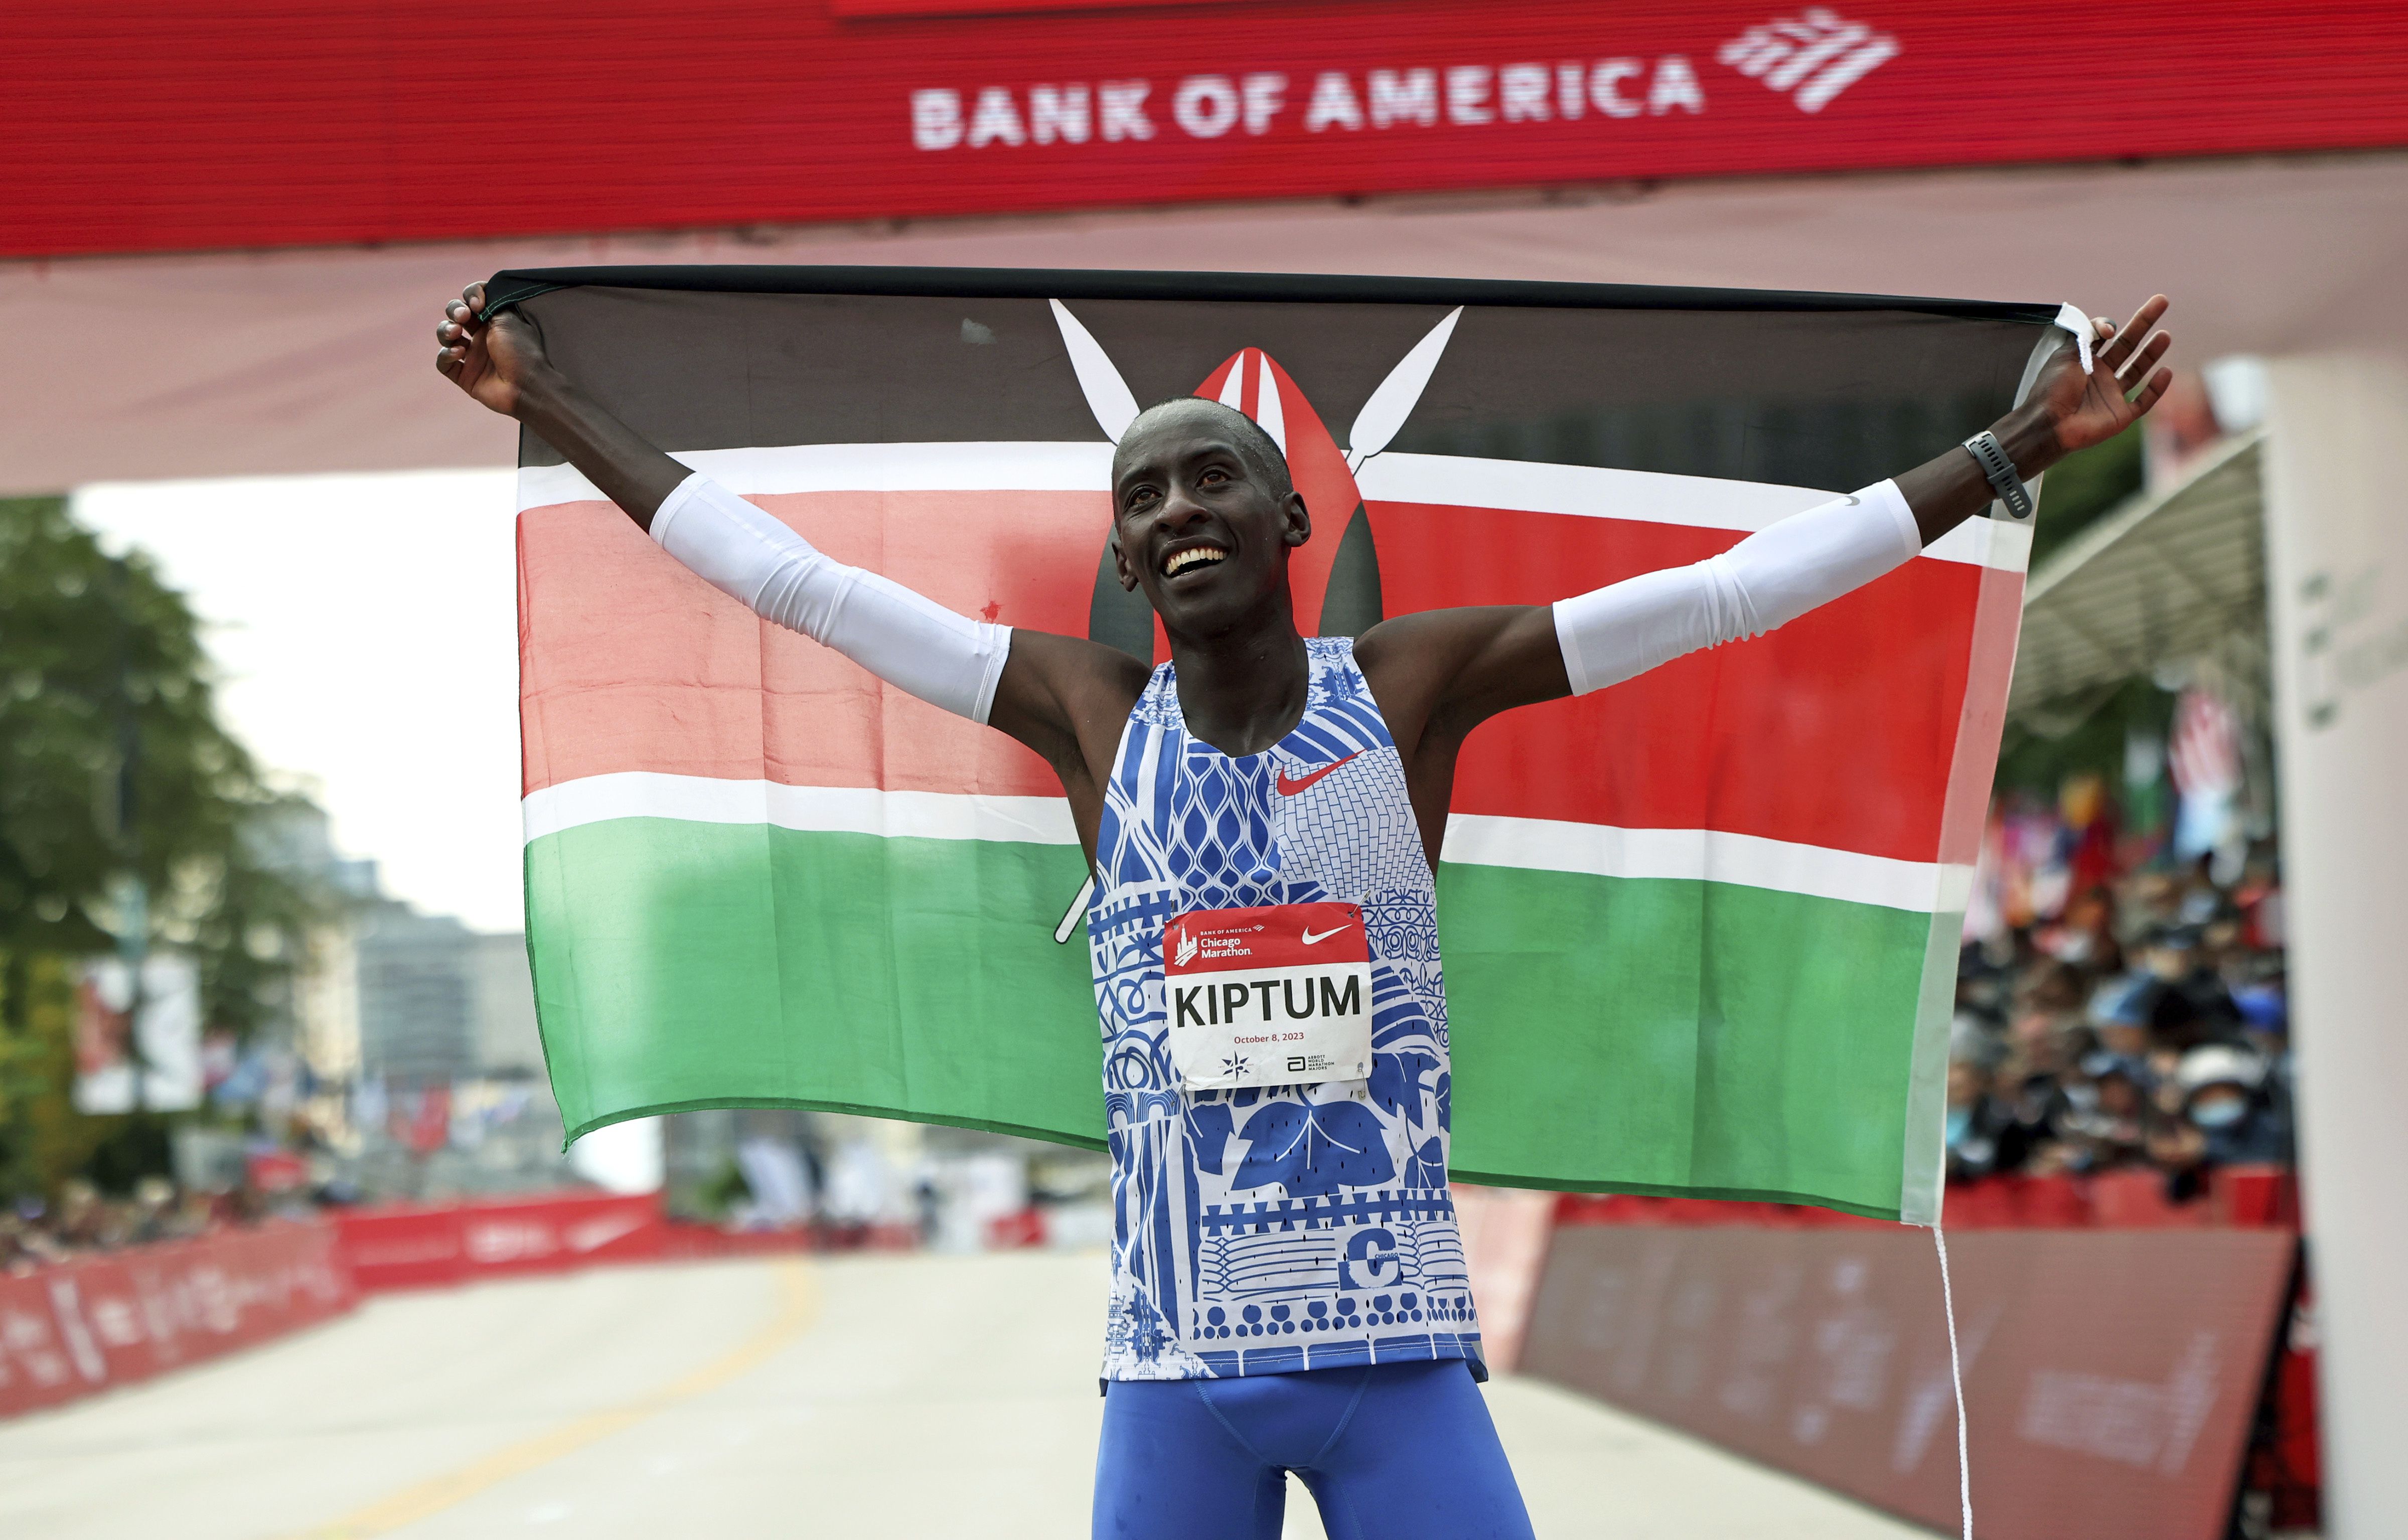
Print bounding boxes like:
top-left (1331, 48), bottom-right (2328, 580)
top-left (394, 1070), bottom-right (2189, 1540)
top-left (1556, 481), bottom-right (1924, 695)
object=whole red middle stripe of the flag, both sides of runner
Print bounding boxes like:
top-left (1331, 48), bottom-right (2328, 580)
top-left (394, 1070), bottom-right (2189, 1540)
top-left (520, 491), bottom-right (2020, 861)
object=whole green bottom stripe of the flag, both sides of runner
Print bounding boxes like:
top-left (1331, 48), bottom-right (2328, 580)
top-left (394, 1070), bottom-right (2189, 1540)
top-left (527, 818), bottom-right (1953, 1217)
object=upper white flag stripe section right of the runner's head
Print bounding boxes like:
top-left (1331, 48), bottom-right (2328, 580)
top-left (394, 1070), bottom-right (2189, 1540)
top-left (1356, 452), bottom-right (2032, 573)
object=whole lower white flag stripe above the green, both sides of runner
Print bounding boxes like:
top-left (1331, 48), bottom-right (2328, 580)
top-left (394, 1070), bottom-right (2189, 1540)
top-left (525, 770), bottom-right (1972, 914)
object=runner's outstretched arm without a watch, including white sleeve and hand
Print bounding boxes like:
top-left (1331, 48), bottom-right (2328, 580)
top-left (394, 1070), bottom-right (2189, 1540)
top-left (436, 284), bottom-right (1146, 840)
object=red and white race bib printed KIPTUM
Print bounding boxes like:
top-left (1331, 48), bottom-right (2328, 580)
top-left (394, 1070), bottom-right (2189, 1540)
top-left (1163, 905), bottom-right (1370, 1090)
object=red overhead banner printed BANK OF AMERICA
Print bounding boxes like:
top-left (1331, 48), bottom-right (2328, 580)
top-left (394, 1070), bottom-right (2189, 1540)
top-left (0, 0), bottom-right (2408, 257)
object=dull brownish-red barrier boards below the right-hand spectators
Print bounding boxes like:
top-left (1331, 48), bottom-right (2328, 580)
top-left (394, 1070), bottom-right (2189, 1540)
top-left (1522, 1225), bottom-right (2297, 1540)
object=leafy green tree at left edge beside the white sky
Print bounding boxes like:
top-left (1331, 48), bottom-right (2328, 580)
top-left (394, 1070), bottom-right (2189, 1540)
top-left (0, 498), bottom-right (332, 1186)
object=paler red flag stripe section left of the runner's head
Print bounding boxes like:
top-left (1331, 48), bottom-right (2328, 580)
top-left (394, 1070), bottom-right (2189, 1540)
top-left (518, 491), bottom-right (1110, 797)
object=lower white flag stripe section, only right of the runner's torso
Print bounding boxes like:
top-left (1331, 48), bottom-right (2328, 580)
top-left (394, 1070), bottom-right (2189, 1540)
top-left (1445, 813), bottom-right (1972, 914)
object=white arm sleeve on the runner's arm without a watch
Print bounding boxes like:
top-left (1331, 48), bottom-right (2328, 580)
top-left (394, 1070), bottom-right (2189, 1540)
top-left (653, 472), bottom-right (1011, 722)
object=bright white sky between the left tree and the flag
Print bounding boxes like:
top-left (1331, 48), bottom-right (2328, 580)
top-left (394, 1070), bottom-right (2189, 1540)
top-left (72, 469), bottom-right (525, 931)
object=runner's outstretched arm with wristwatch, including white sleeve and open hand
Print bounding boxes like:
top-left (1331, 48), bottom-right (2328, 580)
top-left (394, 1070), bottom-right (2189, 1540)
top-left (1358, 293), bottom-right (2172, 765)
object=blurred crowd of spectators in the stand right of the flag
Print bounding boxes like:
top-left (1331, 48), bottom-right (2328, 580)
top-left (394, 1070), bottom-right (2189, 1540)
top-left (1948, 852), bottom-right (2293, 1201)
